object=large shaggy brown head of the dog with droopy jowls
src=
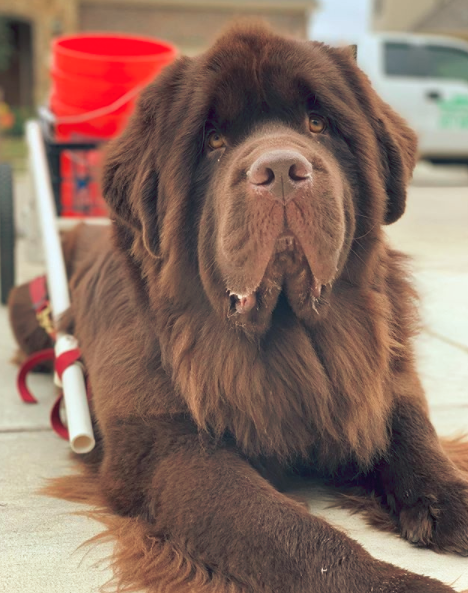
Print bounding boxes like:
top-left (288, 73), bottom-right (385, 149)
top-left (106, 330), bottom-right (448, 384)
top-left (104, 27), bottom-right (416, 333)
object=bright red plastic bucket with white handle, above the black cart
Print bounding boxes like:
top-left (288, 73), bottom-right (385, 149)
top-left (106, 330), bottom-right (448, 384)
top-left (50, 33), bottom-right (177, 138)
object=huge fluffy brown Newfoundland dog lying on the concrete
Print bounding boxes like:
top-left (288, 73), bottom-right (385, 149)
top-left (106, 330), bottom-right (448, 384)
top-left (32, 26), bottom-right (468, 593)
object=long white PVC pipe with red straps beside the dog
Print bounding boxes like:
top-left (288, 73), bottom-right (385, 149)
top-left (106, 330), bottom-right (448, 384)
top-left (26, 121), bottom-right (95, 453)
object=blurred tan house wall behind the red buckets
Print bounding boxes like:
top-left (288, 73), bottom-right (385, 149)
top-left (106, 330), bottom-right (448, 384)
top-left (0, 0), bottom-right (316, 104)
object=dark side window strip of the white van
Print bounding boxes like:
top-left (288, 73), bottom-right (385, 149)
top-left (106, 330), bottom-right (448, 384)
top-left (384, 42), bottom-right (468, 81)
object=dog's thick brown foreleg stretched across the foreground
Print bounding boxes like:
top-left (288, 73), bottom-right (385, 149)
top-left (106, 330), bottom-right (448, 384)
top-left (101, 418), bottom-right (452, 593)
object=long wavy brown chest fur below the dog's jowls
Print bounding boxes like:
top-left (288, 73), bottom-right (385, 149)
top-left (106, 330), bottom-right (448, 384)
top-left (161, 280), bottom-right (391, 468)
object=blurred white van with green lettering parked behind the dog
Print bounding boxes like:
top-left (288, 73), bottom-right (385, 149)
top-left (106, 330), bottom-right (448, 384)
top-left (357, 33), bottom-right (468, 163)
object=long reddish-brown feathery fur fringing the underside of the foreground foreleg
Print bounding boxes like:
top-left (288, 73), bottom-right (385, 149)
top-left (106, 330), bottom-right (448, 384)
top-left (41, 463), bottom-right (246, 593)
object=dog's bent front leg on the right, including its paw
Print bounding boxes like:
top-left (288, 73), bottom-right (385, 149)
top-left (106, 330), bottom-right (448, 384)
top-left (380, 387), bottom-right (468, 555)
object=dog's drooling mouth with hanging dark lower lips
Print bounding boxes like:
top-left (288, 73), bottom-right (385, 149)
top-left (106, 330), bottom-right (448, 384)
top-left (227, 232), bottom-right (330, 325)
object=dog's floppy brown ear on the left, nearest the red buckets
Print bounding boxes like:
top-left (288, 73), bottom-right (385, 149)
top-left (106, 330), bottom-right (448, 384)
top-left (102, 59), bottom-right (188, 257)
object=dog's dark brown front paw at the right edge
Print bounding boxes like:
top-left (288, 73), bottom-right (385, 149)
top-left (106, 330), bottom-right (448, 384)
top-left (399, 480), bottom-right (468, 556)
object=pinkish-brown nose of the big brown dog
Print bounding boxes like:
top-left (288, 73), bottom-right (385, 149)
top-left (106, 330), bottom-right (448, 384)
top-left (247, 150), bottom-right (312, 204)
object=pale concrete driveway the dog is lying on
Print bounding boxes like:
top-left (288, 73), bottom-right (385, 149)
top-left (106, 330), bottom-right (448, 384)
top-left (0, 165), bottom-right (468, 593)
